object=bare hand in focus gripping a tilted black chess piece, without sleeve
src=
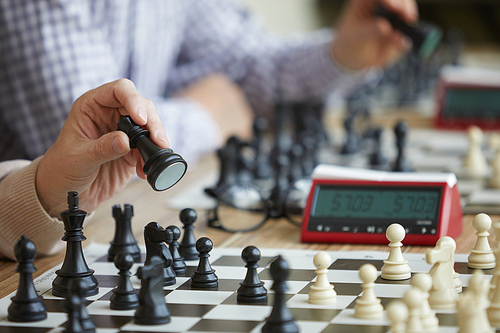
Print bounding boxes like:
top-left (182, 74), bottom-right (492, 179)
top-left (36, 79), bottom-right (169, 217)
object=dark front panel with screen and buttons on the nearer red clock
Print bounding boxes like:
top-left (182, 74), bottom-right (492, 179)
top-left (308, 185), bottom-right (442, 234)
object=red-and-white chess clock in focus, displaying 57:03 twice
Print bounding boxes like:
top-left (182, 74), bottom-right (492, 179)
top-left (302, 164), bottom-right (462, 245)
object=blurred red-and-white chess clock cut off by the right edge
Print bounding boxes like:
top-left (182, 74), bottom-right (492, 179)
top-left (434, 66), bottom-right (500, 130)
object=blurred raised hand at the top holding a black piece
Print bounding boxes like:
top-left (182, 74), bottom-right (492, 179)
top-left (332, 0), bottom-right (418, 70)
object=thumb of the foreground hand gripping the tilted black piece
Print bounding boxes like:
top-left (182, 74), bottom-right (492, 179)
top-left (87, 131), bottom-right (130, 165)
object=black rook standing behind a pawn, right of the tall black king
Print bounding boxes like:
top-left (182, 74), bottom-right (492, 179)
top-left (108, 204), bottom-right (141, 262)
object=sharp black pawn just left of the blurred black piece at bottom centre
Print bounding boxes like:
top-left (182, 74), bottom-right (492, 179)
top-left (237, 246), bottom-right (267, 303)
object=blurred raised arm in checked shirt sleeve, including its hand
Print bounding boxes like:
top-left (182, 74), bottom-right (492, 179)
top-left (169, 0), bottom-right (415, 114)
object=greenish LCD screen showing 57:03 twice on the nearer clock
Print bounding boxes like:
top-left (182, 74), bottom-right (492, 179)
top-left (311, 185), bottom-right (441, 220)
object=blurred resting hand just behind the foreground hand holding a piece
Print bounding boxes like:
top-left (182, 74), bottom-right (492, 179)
top-left (178, 74), bottom-right (254, 146)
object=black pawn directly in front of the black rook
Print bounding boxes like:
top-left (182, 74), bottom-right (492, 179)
top-left (110, 252), bottom-right (139, 310)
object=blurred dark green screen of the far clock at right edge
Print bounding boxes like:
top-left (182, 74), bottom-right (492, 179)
top-left (443, 88), bottom-right (500, 119)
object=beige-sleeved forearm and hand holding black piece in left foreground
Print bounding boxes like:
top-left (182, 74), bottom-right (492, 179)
top-left (0, 79), bottom-right (169, 258)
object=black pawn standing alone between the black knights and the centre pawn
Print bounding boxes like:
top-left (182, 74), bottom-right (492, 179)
top-left (191, 237), bottom-right (219, 289)
